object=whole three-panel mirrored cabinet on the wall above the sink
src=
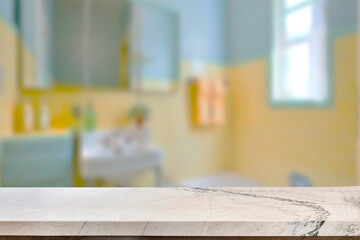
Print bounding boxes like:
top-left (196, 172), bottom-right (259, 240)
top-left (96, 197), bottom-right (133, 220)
top-left (16, 0), bottom-right (179, 91)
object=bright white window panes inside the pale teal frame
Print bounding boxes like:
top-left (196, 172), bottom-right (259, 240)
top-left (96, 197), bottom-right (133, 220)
top-left (270, 0), bottom-right (329, 104)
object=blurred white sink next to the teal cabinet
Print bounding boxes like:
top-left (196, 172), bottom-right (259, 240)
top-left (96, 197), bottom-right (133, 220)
top-left (80, 130), bottom-right (164, 186)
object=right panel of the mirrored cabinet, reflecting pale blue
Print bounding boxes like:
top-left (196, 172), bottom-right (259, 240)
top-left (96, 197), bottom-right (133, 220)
top-left (132, 3), bottom-right (179, 91)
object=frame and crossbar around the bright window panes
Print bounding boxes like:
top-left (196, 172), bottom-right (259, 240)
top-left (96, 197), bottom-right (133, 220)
top-left (268, 0), bottom-right (333, 108)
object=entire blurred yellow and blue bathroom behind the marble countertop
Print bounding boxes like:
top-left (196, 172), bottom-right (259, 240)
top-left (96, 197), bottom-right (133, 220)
top-left (0, 0), bottom-right (360, 187)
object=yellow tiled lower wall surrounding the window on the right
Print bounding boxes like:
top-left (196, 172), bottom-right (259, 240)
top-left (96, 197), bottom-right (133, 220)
top-left (228, 36), bottom-right (358, 186)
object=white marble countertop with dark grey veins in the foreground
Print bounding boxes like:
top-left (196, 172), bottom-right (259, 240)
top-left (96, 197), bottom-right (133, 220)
top-left (0, 187), bottom-right (360, 236)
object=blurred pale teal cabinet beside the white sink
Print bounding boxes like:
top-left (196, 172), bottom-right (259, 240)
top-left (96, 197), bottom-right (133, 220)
top-left (0, 134), bottom-right (74, 187)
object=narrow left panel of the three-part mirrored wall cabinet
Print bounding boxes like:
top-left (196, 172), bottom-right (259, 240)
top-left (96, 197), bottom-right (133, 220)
top-left (16, 0), bottom-right (54, 89)
